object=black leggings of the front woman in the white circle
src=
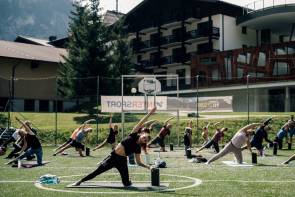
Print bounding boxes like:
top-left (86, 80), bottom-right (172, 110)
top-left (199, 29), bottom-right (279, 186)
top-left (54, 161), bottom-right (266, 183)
top-left (81, 151), bottom-right (131, 186)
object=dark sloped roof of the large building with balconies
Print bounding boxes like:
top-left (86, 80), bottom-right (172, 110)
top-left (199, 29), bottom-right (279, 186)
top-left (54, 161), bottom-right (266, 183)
top-left (124, 0), bottom-right (243, 32)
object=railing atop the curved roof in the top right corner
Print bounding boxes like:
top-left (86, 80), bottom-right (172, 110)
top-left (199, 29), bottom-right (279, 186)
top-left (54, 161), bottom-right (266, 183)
top-left (243, 0), bottom-right (295, 15)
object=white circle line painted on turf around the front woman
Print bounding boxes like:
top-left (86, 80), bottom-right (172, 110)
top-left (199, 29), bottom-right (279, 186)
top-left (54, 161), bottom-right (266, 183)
top-left (34, 173), bottom-right (202, 194)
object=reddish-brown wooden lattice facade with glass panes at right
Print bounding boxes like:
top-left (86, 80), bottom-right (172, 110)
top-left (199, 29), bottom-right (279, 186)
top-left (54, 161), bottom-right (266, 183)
top-left (191, 41), bottom-right (295, 87)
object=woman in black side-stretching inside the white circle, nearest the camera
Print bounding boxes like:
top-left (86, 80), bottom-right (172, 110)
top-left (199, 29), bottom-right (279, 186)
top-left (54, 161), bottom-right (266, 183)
top-left (74, 108), bottom-right (156, 186)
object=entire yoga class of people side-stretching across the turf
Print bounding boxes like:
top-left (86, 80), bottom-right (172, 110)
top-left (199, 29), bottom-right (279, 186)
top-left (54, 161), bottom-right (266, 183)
top-left (2, 111), bottom-right (295, 186)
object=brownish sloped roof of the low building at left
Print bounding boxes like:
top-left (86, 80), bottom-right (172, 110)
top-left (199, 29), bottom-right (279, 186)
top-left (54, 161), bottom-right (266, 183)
top-left (0, 40), bottom-right (68, 63)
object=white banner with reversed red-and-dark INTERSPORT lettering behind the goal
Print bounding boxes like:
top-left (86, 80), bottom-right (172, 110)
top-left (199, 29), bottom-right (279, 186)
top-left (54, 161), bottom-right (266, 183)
top-left (101, 96), bottom-right (167, 112)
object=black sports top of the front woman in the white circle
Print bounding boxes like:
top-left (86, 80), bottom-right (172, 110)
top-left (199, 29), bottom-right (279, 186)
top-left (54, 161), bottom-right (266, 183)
top-left (121, 133), bottom-right (141, 156)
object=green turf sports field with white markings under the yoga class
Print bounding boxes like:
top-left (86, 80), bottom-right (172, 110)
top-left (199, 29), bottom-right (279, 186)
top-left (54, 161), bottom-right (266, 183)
top-left (0, 147), bottom-right (295, 197)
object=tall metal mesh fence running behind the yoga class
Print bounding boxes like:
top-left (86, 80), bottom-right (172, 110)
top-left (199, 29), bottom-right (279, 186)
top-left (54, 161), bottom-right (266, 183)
top-left (0, 75), bottom-right (295, 144)
